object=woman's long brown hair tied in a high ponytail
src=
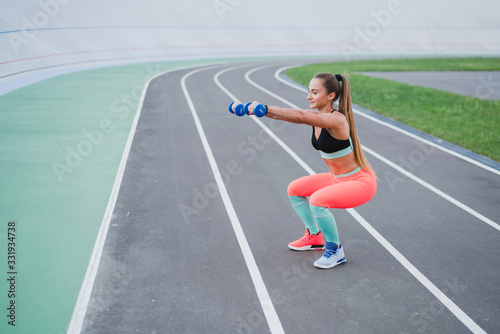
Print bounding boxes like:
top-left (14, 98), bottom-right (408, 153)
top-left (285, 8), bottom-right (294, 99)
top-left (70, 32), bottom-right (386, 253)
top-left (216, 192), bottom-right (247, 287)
top-left (314, 73), bottom-right (376, 176)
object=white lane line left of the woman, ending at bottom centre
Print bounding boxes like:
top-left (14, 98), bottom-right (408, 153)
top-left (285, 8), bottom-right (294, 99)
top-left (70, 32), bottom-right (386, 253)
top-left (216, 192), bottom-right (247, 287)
top-left (185, 69), bottom-right (284, 334)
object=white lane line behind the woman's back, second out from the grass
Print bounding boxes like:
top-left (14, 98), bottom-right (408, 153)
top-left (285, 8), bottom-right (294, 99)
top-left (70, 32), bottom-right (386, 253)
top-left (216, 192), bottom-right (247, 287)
top-left (250, 67), bottom-right (500, 231)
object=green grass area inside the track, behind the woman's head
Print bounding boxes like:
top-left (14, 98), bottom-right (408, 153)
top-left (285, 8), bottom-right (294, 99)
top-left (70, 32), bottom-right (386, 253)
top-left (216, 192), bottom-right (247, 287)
top-left (287, 58), bottom-right (500, 161)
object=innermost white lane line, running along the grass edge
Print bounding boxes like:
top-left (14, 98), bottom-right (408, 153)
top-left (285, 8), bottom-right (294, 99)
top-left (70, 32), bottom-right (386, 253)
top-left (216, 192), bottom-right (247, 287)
top-left (274, 65), bottom-right (500, 175)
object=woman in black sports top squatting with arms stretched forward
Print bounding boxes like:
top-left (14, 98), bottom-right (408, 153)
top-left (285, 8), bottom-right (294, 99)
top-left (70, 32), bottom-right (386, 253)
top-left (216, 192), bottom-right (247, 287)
top-left (234, 73), bottom-right (377, 269)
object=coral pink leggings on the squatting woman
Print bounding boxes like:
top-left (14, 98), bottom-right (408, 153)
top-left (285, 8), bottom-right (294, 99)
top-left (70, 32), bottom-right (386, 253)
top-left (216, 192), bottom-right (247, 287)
top-left (288, 169), bottom-right (377, 209)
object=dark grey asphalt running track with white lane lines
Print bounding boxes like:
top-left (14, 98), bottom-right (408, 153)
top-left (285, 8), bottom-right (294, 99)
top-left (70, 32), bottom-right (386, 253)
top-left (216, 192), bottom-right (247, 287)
top-left (72, 62), bottom-right (500, 333)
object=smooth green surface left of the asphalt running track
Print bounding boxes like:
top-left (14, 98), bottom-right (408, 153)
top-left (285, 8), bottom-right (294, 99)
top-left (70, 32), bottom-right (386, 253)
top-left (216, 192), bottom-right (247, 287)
top-left (0, 60), bottom-right (227, 334)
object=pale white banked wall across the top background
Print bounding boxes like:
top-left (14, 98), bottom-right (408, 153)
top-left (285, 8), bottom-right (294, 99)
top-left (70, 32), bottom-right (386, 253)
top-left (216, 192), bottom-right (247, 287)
top-left (0, 0), bottom-right (500, 87)
